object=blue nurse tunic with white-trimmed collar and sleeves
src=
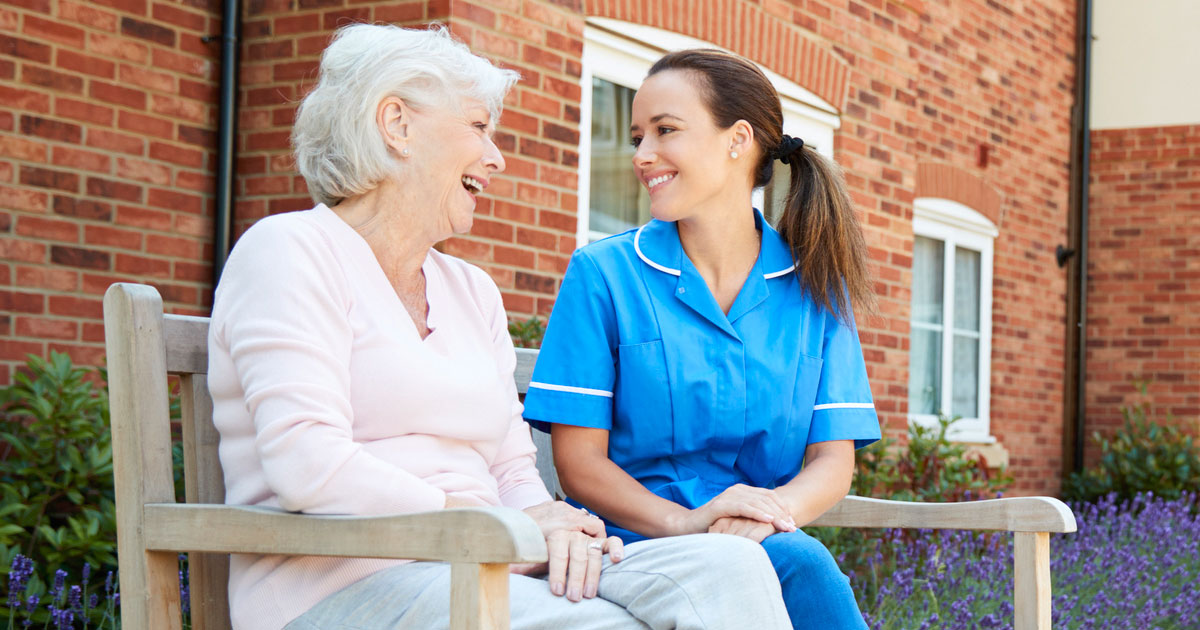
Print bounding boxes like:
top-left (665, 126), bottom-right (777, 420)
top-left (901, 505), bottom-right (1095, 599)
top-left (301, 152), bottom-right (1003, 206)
top-left (524, 210), bottom-right (880, 542)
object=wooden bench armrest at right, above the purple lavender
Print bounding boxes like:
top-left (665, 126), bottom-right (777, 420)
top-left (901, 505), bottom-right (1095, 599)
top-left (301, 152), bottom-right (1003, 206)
top-left (810, 496), bottom-right (1075, 533)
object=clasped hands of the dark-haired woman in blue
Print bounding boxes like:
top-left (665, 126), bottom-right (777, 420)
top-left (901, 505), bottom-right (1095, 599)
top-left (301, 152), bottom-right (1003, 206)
top-left (676, 484), bottom-right (796, 542)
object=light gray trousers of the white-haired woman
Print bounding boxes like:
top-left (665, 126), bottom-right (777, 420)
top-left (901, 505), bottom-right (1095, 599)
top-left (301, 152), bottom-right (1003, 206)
top-left (284, 534), bottom-right (792, 630)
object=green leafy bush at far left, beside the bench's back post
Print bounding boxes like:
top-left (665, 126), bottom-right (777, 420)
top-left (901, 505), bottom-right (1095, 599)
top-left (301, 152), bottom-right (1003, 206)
top-left (0, 352), bottom-right (116, 597)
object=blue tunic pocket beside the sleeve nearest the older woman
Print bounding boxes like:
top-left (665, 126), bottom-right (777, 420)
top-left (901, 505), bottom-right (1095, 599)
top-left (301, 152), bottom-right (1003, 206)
top-left (608, 340), bottom-right (672, 458)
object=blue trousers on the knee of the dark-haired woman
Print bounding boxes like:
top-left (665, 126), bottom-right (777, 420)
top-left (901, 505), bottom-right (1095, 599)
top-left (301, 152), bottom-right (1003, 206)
top-left (762, 529), bottom-right (866, 630)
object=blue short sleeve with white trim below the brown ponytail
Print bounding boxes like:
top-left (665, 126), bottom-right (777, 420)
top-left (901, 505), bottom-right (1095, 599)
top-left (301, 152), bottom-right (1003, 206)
top-left (808, 304), bottom-right (882, 449)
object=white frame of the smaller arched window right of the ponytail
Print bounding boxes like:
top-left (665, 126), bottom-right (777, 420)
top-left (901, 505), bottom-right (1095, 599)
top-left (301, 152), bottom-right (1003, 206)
top-left (908, 197), bottom-right (1000, 443)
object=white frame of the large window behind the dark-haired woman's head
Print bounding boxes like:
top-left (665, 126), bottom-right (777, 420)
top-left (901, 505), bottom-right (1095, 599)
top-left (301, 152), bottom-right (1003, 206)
top-left (576, 17), bottom-right (841, 247)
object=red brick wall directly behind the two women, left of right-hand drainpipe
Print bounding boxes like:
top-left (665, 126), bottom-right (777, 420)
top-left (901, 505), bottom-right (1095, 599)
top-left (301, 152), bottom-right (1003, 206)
top-left (0, 0), bottom-right (1089, 492)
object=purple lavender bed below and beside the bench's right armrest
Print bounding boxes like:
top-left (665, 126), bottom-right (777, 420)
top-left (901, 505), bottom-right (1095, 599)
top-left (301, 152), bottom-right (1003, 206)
top-left (851, 492), bottom-right (1200, 630)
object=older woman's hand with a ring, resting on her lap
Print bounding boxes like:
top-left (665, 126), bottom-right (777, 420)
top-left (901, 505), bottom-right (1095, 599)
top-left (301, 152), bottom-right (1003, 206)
top-left (512, 500), bottom-right (624, 601)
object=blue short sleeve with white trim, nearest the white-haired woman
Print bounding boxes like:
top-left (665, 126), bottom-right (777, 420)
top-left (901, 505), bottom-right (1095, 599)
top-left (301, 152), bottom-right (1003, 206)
top-left (524, 251), bottom-right (617, 432)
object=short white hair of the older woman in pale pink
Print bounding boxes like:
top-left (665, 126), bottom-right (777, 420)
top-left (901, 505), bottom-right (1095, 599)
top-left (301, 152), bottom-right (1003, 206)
top-left (292, 24), bottom-right (520, 205)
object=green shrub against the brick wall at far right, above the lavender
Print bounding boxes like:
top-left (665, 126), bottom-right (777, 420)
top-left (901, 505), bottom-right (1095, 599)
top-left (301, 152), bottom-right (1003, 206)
top-left (1063, 383), bottom-right (1200, 502)
